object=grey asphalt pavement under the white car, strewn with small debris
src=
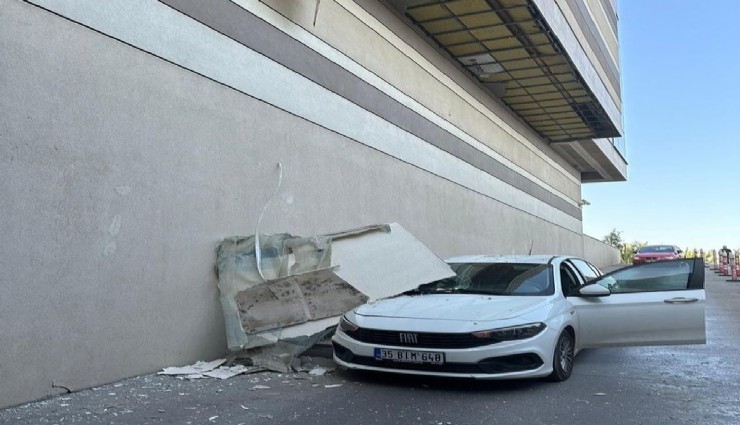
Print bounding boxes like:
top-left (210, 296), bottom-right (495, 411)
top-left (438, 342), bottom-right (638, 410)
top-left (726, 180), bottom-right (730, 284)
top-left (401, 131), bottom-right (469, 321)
top-left (0, 271), bottom-right (740, 425)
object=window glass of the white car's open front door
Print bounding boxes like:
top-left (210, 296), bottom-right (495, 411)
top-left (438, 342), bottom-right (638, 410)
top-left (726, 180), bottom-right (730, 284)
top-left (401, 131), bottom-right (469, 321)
top-left (596, 261), bottom-right (694, 294)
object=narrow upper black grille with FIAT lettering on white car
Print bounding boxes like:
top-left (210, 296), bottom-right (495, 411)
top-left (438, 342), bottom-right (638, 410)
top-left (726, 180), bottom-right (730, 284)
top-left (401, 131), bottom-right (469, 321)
top-left (344, 328), bottom-right (500, 349)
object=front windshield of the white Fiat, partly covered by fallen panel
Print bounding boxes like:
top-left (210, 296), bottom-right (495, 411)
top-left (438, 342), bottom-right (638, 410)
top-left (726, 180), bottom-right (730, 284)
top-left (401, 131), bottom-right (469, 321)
top-left (417, 263), bottom-right (555, 296)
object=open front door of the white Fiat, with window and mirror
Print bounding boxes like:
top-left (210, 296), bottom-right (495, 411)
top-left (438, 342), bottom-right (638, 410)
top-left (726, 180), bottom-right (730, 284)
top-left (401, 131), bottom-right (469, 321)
top-left (568, 258), bottom-right (706, 348)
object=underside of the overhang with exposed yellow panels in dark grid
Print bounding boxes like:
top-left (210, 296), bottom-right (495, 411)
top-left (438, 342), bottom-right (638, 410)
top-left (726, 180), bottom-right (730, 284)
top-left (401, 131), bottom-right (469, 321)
top-left (388, 0), bottom-right (619, 143)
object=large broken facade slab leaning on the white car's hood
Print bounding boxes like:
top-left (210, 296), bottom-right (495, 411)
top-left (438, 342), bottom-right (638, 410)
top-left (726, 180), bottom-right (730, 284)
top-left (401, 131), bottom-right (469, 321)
top-left (217, 223), bottom-right (454, 373)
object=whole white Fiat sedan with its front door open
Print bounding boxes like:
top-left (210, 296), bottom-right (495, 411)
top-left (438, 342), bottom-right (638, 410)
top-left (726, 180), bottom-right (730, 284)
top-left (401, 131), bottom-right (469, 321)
top-left (332, 256), bottom-right (706, 381)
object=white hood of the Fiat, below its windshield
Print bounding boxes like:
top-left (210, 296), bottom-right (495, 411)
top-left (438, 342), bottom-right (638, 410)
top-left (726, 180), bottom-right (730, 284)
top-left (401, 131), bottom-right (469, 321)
top-left (355, 294), bottom-right (550, 321)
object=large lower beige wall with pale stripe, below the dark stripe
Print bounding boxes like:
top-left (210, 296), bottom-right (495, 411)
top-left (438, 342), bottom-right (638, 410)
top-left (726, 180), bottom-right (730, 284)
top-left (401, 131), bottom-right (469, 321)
top-left (0, 0), bottom-right (596, 407)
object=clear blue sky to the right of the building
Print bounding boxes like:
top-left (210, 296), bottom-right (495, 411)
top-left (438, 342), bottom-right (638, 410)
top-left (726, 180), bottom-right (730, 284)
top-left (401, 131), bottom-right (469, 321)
top-left (582, 0), bottom-right (740, 250)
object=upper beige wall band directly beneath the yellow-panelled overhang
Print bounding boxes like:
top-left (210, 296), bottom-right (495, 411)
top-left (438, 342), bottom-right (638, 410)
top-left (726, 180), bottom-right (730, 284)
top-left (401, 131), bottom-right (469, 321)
top-left (256, 0), bottom-right (580, 202)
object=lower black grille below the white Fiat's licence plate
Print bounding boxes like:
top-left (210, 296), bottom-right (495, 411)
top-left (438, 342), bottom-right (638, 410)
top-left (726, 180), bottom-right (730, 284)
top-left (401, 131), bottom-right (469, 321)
top-left (333, 342), bottom-right (544, 374)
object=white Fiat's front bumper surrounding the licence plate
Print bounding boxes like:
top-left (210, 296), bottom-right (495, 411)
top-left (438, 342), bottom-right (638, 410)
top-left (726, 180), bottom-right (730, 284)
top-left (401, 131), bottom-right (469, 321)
top-left (332, 322), bottom-right (558, 379)
